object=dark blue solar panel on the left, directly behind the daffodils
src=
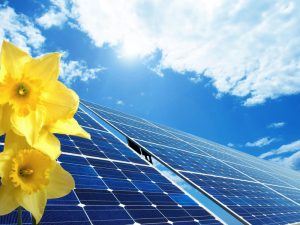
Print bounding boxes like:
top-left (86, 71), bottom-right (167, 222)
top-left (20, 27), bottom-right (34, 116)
top-left (0, 106), bottom-right (222, 225)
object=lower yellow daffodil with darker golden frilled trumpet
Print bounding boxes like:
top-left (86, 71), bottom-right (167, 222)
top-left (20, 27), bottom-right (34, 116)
top-left (0, 134), bottom-right (75, 223)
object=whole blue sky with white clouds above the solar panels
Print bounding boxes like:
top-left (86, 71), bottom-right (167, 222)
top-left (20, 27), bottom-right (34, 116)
top-left (0, 0), bottom-right (300, 170)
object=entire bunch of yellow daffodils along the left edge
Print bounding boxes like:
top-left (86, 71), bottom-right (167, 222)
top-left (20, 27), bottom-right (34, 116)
top-left (0, 41), bottom-right (90, 224)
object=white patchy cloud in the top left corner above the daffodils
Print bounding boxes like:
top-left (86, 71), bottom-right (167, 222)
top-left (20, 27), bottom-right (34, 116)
top-left (0, 4), bottom-right (45, 53)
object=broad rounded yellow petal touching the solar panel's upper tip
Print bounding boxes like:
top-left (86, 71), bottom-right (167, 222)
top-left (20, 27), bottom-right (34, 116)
top-left (40, 81), bottom-right (79, 125)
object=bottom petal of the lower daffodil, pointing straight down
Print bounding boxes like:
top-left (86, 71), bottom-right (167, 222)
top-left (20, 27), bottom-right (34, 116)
top-left (16, 190), bottom-right (47, 223)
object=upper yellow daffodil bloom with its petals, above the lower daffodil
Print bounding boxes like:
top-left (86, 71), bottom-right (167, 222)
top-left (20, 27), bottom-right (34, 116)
top-left (0, 41), bottom-right (90, 159)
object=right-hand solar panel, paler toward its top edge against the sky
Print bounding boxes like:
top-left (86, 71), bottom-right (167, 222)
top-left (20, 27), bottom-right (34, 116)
top-left (83, 101), bottom-right (300, 224)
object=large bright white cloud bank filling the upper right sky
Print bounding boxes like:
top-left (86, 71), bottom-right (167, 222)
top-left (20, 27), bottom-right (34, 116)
top-left (45, 0), bottom-right (300, 106)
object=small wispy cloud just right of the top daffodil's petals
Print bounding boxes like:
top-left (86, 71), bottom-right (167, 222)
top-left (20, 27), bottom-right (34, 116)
top-left (60, 59), bottom-right (105, 85)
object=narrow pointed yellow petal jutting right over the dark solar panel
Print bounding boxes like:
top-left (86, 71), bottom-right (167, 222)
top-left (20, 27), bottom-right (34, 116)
top-left (49, 118), bottom-right (91, 139)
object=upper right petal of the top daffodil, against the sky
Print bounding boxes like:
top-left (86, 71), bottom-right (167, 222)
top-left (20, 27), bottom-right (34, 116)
top-left (25, 52), bottom-right (61, 86)
